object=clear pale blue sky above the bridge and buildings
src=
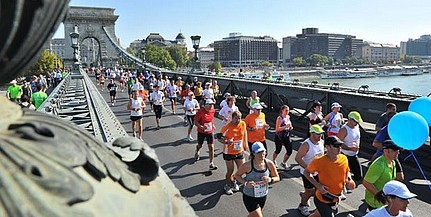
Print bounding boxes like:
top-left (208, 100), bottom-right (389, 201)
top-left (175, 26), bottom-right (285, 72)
top-left (54, 0), bottom-right (431, 50)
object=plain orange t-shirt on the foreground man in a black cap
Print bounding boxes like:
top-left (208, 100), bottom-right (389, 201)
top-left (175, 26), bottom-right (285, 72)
top-left (307, 154), bottom-right (350, 203)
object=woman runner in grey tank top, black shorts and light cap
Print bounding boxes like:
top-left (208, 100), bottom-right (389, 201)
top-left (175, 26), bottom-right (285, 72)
top-left (235, 142), bottom-right (280, 216)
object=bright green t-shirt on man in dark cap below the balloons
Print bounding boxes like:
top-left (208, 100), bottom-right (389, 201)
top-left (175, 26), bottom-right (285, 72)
top-left (364, 155), bottom-right (397, 208)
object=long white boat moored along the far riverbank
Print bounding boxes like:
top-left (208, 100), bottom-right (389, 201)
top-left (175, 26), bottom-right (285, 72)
top-left (319, 68), bottom-right (377, 79)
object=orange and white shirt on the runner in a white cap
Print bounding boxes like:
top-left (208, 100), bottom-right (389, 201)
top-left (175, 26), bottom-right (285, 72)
top-left (244, 112), bottom-right (266, 142)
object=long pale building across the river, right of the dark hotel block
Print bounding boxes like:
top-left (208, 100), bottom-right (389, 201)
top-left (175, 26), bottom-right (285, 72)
top-left (362, 42), bottom-right (400, 61)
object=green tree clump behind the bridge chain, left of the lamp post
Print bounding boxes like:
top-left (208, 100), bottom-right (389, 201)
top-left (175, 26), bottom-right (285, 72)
top-left (145, 44), bottom-right (177, 70)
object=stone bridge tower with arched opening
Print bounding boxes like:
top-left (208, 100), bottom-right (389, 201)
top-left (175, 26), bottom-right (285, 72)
top-left (63, 6), bottom-right (120, 67)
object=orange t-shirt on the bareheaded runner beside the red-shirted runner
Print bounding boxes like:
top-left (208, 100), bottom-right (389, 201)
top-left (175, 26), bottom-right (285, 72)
top-left (220, 121), bottom-right (248, 155)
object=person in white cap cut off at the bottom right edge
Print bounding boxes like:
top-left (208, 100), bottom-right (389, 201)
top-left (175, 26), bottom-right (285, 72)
top-left (365, 180), bottom-right (417, 217)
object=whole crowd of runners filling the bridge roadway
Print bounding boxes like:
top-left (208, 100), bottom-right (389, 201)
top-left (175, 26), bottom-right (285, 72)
top-left (95, 70), bottom-right (416, 217)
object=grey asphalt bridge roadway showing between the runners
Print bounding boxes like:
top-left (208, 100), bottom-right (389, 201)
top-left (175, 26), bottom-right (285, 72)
top-left (89, 76), bottom-right (431, 217)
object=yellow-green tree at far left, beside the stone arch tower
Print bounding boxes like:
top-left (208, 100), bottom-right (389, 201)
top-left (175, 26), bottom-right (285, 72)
top-left (24, 50), bottom-right (62, 75)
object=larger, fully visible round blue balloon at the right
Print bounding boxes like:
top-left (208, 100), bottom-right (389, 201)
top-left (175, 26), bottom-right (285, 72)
top-left (388, 111), bottom-right (429, 150)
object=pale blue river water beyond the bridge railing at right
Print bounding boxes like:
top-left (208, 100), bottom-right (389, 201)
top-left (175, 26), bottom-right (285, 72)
top-left (298, 73), bottom-right (431, 96)
